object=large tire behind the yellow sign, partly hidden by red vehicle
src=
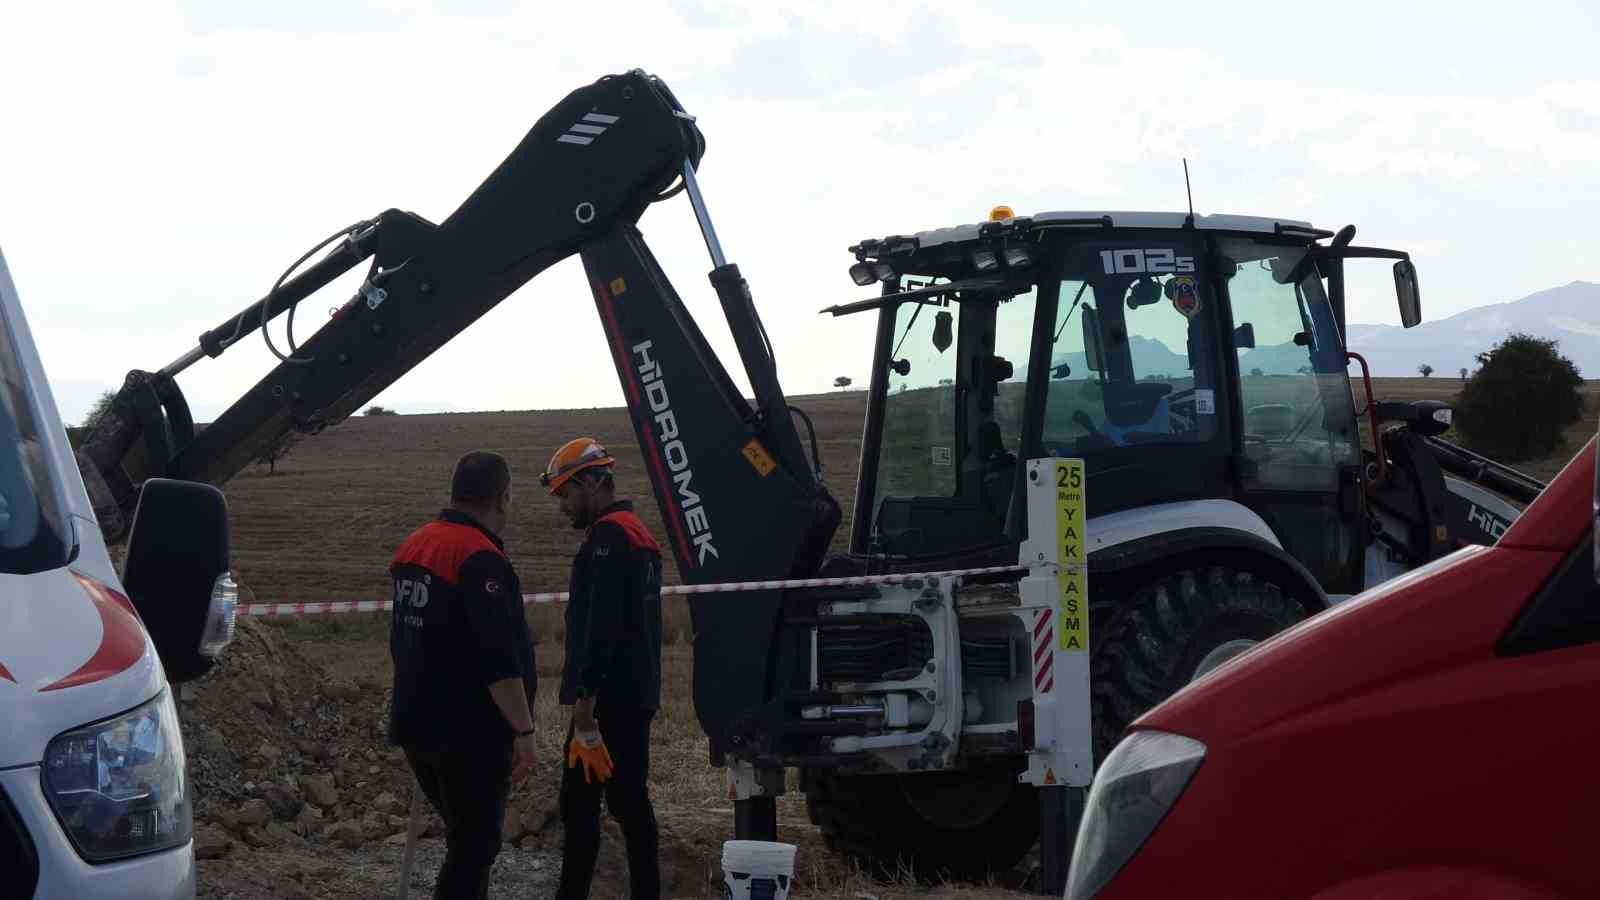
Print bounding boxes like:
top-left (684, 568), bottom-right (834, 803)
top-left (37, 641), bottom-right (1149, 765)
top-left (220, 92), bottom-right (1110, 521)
top-left (1090, 565), bottom-right (1306, 761)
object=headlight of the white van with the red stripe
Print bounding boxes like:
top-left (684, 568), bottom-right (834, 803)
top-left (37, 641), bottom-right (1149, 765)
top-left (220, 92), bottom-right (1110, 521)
top-left (43, 690), bottom-right (194, 863)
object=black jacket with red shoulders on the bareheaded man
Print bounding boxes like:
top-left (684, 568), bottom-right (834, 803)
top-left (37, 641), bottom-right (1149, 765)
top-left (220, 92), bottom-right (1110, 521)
top-left (389, 509), bottom-right (538, 749)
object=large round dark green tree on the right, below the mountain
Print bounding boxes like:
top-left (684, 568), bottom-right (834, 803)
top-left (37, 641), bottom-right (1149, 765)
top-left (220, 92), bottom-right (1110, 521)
top-left (1454, 331), bottom-right (1584, 461)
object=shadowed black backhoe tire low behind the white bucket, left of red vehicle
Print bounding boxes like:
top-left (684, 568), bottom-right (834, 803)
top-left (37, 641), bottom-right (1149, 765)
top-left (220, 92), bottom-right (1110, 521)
top-left (805, 759), bottom-right (1038, 882)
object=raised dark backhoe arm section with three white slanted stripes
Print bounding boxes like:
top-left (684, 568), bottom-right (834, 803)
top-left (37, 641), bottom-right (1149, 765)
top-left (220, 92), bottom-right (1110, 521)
top-left (78, 70), bottom-right (704, 543)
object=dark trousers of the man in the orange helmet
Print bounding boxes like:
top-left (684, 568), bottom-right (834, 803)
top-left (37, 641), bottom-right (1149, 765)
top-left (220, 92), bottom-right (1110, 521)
top-left (555, 708), bottom-right (661, 900)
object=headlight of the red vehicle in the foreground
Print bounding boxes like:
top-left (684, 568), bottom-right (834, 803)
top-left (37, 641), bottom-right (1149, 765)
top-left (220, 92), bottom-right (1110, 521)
top-left (1066, 732), bottom-right (1205, 900)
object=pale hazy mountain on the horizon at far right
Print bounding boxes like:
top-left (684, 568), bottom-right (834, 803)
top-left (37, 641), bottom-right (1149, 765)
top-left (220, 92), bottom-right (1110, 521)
top-left (1346, 282), bottom-right (1600, 378)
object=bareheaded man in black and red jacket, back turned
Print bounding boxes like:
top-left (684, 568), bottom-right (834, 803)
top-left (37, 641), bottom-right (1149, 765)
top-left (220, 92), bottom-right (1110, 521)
top-left (389, 452), bottom-right (538, 898)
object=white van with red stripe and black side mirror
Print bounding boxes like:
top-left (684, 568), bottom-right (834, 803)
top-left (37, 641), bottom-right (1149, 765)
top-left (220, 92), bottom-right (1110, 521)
top-left (0, 245), bottom-right (237, 900)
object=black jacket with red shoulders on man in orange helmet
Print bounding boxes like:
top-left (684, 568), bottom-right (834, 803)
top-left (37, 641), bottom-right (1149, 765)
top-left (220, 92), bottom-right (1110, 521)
top-left (560, 500), bottom-right (661, 709)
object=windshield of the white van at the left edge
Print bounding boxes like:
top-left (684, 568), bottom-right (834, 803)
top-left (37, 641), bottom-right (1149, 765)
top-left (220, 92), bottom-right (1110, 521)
top-left (0, 299), bottom-right (70, 575)
